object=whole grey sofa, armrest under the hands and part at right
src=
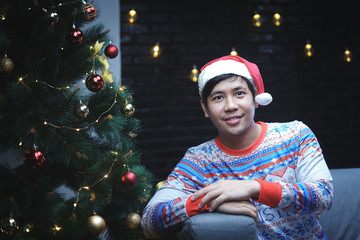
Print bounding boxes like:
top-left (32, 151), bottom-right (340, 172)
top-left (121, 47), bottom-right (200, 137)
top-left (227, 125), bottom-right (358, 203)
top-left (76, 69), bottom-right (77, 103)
top-left (176, 168), bottom-right (360, 240)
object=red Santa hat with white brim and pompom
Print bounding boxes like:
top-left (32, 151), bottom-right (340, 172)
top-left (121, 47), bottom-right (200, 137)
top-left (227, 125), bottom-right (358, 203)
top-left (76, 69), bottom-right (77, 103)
top-left (198, 55), bottom-right (272, 106)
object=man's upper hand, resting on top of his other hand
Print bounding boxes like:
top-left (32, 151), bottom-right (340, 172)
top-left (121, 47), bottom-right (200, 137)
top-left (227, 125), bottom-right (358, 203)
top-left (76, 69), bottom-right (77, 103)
top-left (191, 180), bottom-right (260, 212)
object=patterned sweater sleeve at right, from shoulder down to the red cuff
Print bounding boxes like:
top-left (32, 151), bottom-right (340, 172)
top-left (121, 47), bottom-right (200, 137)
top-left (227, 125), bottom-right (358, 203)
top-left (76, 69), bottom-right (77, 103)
top-left (278, 122), bottom-right (333, 215)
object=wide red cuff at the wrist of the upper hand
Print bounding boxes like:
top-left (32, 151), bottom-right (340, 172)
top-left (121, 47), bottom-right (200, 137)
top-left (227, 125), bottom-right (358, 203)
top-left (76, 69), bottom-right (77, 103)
top-left (254, 180), bottom-right (282, 207)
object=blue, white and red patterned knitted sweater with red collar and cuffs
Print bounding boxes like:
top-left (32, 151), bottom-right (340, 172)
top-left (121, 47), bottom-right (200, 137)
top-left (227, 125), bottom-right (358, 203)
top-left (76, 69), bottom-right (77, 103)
top-left (142, 121), bottom-right (333, 239)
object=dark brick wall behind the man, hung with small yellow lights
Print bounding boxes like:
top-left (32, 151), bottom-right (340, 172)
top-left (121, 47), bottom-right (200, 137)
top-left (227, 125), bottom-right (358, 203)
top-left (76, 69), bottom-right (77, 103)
top-left (120, 0), bottom-right (360, 180)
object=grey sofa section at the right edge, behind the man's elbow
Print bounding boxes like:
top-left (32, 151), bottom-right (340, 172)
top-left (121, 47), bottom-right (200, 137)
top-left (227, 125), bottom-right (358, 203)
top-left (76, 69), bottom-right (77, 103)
top-left (320, 168), bottom-right (360, 240)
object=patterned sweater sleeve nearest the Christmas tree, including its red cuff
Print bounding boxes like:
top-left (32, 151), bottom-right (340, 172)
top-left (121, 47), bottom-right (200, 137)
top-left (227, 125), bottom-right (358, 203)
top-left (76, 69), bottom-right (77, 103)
top-left (141, 153), bottom-right (208, 237)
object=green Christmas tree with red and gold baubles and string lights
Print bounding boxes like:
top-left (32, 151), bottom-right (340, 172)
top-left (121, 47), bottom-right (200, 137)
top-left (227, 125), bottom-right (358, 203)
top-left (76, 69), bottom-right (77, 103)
top-left (0, 0), bottom-right (153, 240)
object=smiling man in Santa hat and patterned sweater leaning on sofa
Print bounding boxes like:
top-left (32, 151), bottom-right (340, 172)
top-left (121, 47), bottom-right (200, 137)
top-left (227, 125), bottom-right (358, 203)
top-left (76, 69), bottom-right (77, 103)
top-left (142, 56), bottom-right (333, 239)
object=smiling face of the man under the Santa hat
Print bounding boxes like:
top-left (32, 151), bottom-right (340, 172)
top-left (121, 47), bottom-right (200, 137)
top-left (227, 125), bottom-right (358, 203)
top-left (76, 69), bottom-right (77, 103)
top-left (201, 76), bottom-right (257, 140)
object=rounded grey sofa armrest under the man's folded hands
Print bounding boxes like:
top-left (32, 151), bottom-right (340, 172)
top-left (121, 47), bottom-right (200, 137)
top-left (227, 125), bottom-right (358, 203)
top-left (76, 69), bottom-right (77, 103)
top-left (177, 212), bottom-right (257, 240)
